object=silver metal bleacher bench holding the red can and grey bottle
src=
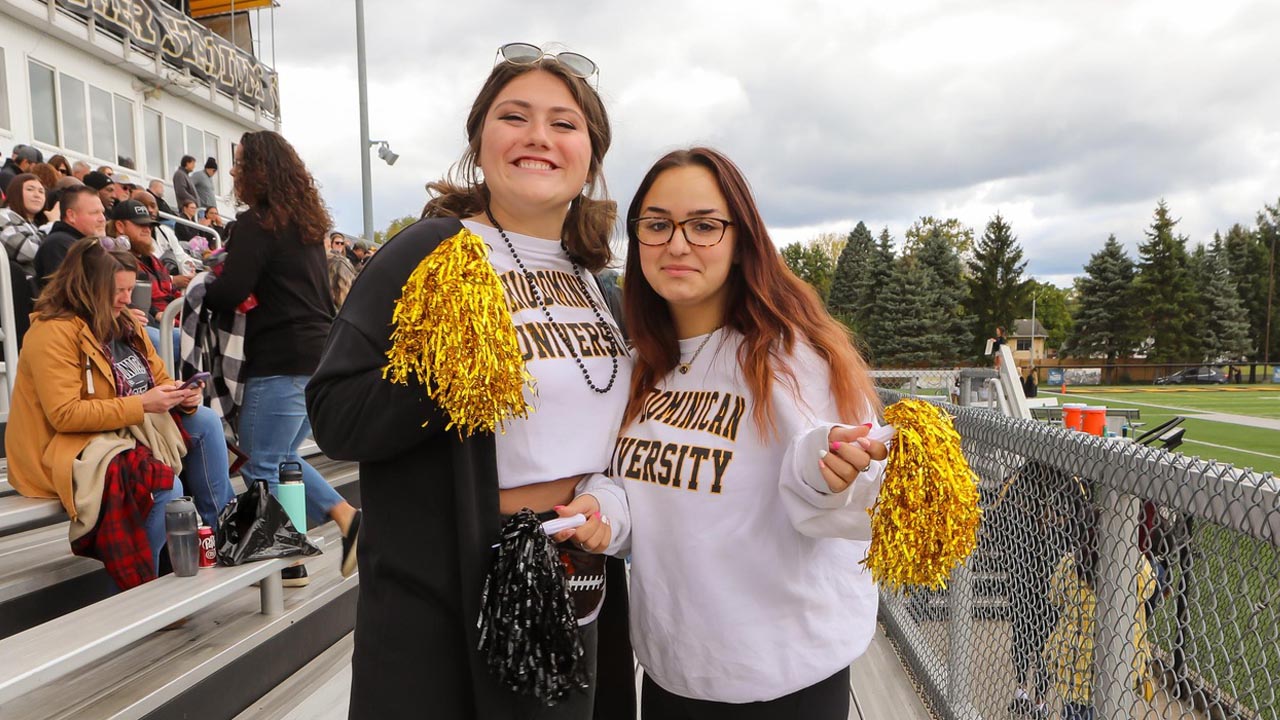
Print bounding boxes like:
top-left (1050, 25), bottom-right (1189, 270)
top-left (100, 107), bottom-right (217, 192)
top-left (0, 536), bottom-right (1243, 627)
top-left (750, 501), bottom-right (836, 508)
top-left (0, 530), bottom-right (335, 706)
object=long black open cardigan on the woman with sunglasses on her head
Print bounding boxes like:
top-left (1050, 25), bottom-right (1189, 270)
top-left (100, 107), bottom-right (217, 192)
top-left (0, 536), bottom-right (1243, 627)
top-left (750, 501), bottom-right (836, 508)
top-left (307, 219), bottom-right (635, 720)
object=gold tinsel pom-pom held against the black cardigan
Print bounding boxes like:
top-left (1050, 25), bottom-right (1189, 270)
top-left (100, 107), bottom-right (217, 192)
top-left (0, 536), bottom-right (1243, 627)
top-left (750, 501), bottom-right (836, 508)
top-left (383, 229), bottom-right (532, 437)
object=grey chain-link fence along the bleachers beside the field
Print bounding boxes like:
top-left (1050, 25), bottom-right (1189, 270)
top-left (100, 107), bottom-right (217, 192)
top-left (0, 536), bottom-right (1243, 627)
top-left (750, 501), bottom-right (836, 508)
top-left (877, 379), bottom-right (1280, 720)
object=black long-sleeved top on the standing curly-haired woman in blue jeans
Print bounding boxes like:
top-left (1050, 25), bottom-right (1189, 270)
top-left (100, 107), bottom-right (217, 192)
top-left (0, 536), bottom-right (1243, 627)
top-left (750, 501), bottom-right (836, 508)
top-left (205, 210), bottom-right (333, 378)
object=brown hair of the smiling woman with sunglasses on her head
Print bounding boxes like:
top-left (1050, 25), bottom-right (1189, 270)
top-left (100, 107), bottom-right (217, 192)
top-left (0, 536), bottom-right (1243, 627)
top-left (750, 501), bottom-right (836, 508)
top-left (422, 58), bottom-right (618, 272)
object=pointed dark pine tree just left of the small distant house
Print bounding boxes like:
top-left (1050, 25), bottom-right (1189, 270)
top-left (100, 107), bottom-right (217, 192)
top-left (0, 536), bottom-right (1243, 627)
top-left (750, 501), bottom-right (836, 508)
top-left (966, 213), bottom-right (1028, 357)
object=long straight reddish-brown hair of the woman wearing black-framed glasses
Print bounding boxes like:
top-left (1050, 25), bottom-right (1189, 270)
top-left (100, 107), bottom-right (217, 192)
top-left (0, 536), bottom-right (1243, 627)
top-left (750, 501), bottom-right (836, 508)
top-left (622, 147), bottom-right (879, 434)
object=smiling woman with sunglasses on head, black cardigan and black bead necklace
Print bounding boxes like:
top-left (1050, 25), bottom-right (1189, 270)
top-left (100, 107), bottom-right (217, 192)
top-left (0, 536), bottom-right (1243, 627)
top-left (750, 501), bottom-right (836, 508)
top-left (307, 44), bottom-right (634, 720)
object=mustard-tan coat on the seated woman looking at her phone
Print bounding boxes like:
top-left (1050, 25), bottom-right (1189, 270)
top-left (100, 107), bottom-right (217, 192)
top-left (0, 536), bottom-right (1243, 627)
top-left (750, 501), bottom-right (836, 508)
top-left (5, 315), bottom-right (173, 520)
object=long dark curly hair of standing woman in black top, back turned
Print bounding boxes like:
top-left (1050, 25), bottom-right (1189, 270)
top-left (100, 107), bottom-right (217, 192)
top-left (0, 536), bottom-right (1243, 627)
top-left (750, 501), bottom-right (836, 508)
top-left (236, 129), bottom-right (333, 245)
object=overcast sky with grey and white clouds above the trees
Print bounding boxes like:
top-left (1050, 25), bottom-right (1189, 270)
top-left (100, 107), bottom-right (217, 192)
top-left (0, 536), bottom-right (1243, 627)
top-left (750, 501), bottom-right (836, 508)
top-left (264, 0), bottom-right (1280, 284)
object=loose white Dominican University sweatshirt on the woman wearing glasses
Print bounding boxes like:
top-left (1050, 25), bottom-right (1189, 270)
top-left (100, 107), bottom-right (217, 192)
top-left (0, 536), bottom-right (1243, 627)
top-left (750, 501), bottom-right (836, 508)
top-left (581, 329), bottom-right (884, 703)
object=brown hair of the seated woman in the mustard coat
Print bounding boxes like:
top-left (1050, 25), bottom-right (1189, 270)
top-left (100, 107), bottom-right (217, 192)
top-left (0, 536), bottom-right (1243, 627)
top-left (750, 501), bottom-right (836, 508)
top-left (36, 237), bottom-right (138, 342)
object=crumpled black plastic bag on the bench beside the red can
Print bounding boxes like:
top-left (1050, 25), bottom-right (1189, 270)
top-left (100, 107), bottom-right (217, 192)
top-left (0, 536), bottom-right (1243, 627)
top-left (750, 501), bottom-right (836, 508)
top-left (215, 480), bottom-right (320, 565)
